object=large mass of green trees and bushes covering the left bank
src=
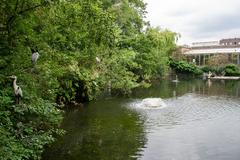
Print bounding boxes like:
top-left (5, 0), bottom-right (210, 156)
top-left (0, 0), bottom-right (176, 160)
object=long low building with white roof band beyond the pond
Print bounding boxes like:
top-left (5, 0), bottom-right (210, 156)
top-left (181, 38), bottom-right (240, 66)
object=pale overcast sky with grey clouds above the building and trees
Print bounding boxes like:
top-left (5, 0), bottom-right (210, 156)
top-left (144, 0), bottom-right (240, 44)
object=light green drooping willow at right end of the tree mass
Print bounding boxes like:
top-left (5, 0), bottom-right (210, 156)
top-left (132, 27), bottom-right (176, 80)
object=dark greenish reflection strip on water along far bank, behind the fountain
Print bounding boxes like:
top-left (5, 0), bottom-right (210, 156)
top-left (132, 78), bottom-right (240, 98)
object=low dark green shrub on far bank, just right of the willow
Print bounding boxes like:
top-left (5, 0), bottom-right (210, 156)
top-left (169, 59), bottom-right (202, 75)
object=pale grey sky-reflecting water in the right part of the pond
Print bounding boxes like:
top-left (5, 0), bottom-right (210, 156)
top-left (135, 93), bottom-right (240, 160)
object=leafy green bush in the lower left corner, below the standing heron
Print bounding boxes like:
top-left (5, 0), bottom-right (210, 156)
top-left (0, 89), bottom-right (63, 160)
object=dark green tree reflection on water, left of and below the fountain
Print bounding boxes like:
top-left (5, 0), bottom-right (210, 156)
top-left (43, 100), bottom-right (146, 160)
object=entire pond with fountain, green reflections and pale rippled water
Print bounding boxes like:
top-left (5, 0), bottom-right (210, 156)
top-left (43, 79), bottom-right (240, 160)
